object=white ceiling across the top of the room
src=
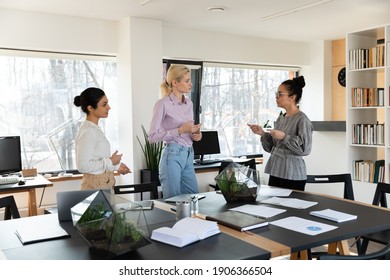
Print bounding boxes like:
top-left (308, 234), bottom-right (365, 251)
top-left (0, 0), bottom-right (390, 41)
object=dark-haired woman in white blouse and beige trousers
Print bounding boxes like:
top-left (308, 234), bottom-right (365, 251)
top-left (73, 87), bottom-right (130, 190)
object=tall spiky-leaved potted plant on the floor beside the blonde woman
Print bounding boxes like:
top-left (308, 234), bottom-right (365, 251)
top-left (137, 126), bottom-right (164, 183)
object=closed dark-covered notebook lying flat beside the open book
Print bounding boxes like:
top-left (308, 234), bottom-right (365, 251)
top-left (206, 210), bottom-right (268, 231)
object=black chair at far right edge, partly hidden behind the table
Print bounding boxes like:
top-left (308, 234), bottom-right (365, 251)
top-left (358, 183), bottom-right (390, 255)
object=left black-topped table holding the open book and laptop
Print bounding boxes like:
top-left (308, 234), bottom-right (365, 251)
top-left (0, 201), bottom-right (270, 260)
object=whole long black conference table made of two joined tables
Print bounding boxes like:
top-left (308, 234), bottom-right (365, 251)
top-left (0, 188), bottom-right (390, 260)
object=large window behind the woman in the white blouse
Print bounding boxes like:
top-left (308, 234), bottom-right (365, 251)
top-left (0, 51), bottom-right (118, 172)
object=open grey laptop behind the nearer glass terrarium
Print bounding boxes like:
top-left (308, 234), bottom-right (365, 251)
top-left (57, 190), bottom-right (99, 222)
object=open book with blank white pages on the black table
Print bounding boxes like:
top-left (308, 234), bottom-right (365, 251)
top-left (151, 217), bottom-right (220, 248)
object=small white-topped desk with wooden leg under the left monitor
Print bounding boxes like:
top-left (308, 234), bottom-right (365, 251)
top-left (0, 175), bottom-right (53, 216)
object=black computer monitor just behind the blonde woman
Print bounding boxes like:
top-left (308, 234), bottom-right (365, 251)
top-left (192, 131), bottom-right (221, 162)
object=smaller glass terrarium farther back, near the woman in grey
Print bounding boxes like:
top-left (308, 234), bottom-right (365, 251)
top-left (215, 162), bottom-right (260, 202)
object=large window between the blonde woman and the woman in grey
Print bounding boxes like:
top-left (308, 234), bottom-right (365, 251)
top-left (200, 63), bottom-right (298, 157)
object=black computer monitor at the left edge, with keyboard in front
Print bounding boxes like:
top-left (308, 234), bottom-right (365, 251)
top-left (0, 136), bottom-right (22, 174)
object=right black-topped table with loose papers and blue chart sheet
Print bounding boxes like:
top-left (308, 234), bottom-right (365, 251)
top-left (193, 191), bottom-right (390, 256)
